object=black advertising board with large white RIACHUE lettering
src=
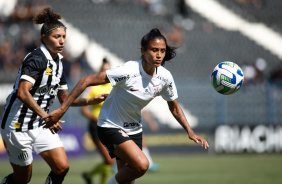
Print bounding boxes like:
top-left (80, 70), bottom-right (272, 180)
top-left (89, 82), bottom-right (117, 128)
top-left (215, 125), bottom-right (282, 153)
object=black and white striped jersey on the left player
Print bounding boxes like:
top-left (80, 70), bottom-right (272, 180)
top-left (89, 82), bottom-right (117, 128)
top-left (1, 44), bottom-right (68, 132)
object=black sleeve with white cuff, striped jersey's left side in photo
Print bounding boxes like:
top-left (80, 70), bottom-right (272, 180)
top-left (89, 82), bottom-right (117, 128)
top-left (21, 57), bottom-right (46, 84)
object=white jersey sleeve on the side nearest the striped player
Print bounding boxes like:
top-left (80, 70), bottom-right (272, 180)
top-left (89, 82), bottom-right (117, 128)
top-left (106, 63), bottom-right (129, 87)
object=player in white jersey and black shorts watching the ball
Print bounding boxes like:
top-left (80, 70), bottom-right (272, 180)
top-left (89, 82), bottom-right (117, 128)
top-left (44, 29), bottom-right (209, 184)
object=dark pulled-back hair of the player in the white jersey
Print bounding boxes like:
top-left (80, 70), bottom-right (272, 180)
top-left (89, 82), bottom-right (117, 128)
top-left (141, 28), bottom-right (176, 66)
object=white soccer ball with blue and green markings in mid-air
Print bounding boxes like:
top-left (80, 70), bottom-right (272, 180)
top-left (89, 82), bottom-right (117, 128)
top-left (211, 61), bottom-right (244, 95)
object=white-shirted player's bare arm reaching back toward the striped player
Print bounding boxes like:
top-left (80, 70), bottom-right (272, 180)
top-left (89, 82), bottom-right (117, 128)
top-left (42, 72), bottom-right (109, 128)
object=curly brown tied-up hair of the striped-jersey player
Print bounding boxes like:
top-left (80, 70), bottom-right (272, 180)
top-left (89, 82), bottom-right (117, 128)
top-left (33, 7), bottom-right (66, 35)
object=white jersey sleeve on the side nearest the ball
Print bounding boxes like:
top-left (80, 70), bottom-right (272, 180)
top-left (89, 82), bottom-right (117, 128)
top-left (161, 73), bottom-right (178, 101)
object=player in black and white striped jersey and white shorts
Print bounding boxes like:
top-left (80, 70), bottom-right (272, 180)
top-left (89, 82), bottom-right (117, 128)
top-left (1, 7), bottom-right (107, 184)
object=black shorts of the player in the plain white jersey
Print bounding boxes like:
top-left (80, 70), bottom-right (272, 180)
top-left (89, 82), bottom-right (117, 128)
top-left (97, 126), bottom-right (142, 160)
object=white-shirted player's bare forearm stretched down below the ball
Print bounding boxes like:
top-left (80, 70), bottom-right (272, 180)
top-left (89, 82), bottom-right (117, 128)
top-left (167, 100), bottom-right (209, 149)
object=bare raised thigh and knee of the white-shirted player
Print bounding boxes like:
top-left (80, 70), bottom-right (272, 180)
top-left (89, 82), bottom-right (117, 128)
top-left (114, 140), bottom-right (149, 170)
